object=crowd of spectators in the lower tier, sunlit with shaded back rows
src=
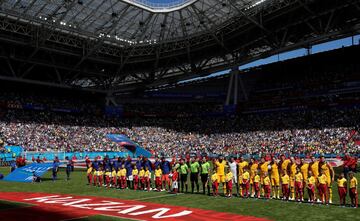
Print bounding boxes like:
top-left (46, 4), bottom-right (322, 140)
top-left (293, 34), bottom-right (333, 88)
top-left (0, 102), bottom-right (360, 156)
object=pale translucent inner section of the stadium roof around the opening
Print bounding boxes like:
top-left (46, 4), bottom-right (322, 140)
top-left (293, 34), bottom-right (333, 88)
top-left (1, 0), bottom-right (264, 44)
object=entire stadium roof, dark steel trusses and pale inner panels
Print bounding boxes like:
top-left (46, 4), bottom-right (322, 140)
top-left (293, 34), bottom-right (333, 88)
top-left (0, 0), bottom-right (360, 92)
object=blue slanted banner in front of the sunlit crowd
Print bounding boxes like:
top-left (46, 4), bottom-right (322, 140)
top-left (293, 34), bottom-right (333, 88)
top-left (107, 134), bottom-right (151, 157)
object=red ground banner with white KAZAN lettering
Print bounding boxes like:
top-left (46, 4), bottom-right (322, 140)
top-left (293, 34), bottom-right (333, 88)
top-left (0, 192), bottom-right (266, 221)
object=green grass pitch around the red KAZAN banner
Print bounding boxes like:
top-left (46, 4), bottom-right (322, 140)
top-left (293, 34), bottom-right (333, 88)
top-left (0, 168), bottom-right (360, 221)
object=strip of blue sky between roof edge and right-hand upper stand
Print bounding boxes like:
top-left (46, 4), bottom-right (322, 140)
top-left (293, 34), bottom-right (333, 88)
top-left (179, 34), bottom-right (360, 83)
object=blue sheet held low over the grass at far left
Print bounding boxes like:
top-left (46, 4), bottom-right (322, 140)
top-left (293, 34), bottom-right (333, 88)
top-left (3, 163), bottom-right (59, 183)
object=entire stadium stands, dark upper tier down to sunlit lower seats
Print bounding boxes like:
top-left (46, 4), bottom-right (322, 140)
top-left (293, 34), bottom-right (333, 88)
top-left (0, 47), bottom-right (360, 159)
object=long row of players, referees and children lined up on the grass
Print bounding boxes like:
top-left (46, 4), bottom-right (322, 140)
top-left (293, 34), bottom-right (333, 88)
top-left (69, 155), bottom-right (358, 208)
